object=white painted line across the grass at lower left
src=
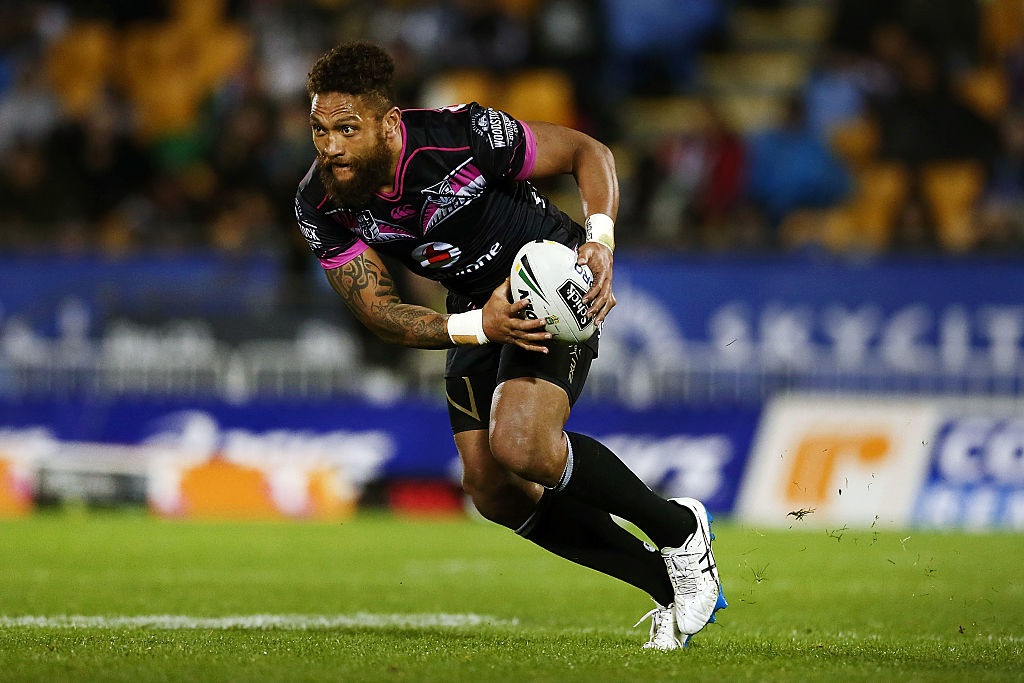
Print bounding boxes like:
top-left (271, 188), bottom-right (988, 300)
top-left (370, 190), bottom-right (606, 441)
top-left (0, 612), bottom-right (517, 631)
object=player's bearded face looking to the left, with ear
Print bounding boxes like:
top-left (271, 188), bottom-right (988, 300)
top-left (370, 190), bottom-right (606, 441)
top-left (309, 92), bottom-right (397, 208)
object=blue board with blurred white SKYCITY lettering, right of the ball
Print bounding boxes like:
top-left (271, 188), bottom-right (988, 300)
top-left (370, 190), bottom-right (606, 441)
top-left (606, 254), bottom-right (1024, 377)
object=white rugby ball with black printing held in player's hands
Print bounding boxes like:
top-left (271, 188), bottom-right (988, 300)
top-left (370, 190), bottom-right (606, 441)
top-left (509, 240), bottom-right (594, 344)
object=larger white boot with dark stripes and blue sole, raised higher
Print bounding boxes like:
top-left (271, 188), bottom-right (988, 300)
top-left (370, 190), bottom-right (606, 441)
top-left (662, 498), bottom-right (728, 642)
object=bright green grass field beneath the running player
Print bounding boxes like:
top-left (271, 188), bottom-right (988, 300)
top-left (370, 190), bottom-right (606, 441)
top-left (0, 511), bottom-right (1024, 683)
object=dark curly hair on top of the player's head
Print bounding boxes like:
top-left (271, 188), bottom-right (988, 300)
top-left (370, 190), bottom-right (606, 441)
top-left (306, 41), bottom-right (394, 114)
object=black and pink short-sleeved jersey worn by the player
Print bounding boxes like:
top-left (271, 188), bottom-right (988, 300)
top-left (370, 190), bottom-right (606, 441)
top-left (295, 102), bottom-right (583, 301)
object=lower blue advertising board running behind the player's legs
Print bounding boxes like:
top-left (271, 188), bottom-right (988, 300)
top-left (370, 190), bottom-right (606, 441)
top-left (0, 399), bottom-right (758, 512)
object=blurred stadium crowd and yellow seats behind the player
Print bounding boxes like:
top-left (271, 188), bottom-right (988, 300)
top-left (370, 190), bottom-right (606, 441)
top-left (0, 0), bottom-right (1024, 262)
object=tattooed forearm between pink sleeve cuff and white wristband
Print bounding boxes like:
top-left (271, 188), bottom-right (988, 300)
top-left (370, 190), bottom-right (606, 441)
top-left (326, 256), bottom-right (452, 348)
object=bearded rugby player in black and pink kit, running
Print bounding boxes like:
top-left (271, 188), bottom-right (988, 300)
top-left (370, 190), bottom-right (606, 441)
top-left (295, 41), bottom-right (726, 649)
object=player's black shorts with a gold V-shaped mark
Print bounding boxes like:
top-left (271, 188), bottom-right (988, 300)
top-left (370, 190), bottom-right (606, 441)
top-left (444, 296), bottom-right (600, 434)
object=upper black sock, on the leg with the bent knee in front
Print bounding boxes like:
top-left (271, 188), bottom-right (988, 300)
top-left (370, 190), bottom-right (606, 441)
top-left (557, 432), bottom-right (697, 548)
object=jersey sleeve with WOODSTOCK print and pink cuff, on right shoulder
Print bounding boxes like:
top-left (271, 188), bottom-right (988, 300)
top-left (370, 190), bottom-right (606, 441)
top-left (469, 103), bottom-right (537, 180)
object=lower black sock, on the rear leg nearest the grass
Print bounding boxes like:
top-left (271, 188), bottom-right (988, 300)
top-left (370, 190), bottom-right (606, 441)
top-left (516, 490), bottom-right (674, 605)
